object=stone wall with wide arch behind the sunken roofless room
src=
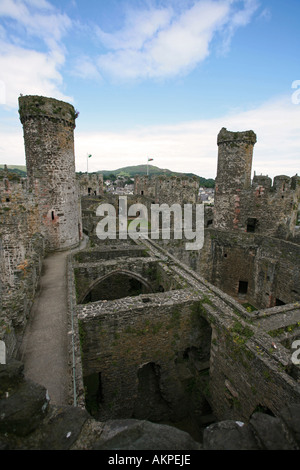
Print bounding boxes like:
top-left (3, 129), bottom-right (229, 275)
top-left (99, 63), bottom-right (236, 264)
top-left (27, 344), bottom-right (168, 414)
top-left (73, 243), bottom-right (184, 303)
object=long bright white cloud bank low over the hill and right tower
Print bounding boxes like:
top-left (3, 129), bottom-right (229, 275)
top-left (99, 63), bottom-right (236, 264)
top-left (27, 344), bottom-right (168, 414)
top-left (75, 97), bottom-right (300, 178)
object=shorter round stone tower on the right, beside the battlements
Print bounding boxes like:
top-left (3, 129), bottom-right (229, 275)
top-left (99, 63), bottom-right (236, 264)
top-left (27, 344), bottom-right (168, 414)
top-left (214, 128), bottom-right (256, 230)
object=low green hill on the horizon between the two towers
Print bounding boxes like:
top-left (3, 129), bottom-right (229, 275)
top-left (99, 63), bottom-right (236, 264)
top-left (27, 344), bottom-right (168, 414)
top-left (97, 165), bottom-right (215, 188)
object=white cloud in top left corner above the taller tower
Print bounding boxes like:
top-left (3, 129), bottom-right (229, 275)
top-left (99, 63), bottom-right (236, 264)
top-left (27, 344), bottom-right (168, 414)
top-left (0, 0), bottom-right (72, 107)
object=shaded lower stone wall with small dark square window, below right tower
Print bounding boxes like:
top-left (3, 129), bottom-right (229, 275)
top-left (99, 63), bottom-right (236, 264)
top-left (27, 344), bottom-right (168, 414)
top-left (156, 228), bottom-right (300, 308)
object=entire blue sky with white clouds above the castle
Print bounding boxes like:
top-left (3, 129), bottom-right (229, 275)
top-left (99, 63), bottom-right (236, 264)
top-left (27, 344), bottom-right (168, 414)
top-left (0, 0), bottom-right (300, 178)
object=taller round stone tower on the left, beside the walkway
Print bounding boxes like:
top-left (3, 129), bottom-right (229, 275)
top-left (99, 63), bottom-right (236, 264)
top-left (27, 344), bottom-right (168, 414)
top-left (19, 96), bottom-right (80, 251)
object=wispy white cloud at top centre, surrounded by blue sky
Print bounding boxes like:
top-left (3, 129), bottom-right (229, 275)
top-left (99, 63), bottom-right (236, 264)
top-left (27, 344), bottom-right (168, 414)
top-left (96, 0), bottom-right (258, 79)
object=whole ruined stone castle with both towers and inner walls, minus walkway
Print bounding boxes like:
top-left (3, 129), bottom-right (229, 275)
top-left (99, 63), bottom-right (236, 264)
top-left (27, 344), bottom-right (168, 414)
top-left (0, 96), bottom-right (300, 448)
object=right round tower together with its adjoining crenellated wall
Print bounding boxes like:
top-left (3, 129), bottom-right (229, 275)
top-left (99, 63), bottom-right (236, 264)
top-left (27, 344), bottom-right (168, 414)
top-left (213, 129), bottom-right (300, 239)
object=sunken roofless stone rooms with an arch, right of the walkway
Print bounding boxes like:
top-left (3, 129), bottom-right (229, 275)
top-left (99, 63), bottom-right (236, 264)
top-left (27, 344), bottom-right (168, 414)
top-left (73, 241), bottom-right (215, 442)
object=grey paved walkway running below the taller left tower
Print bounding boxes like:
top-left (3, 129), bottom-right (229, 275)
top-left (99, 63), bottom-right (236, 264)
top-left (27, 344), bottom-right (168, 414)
top-left (21, 251), bottom-right (71, 405)
